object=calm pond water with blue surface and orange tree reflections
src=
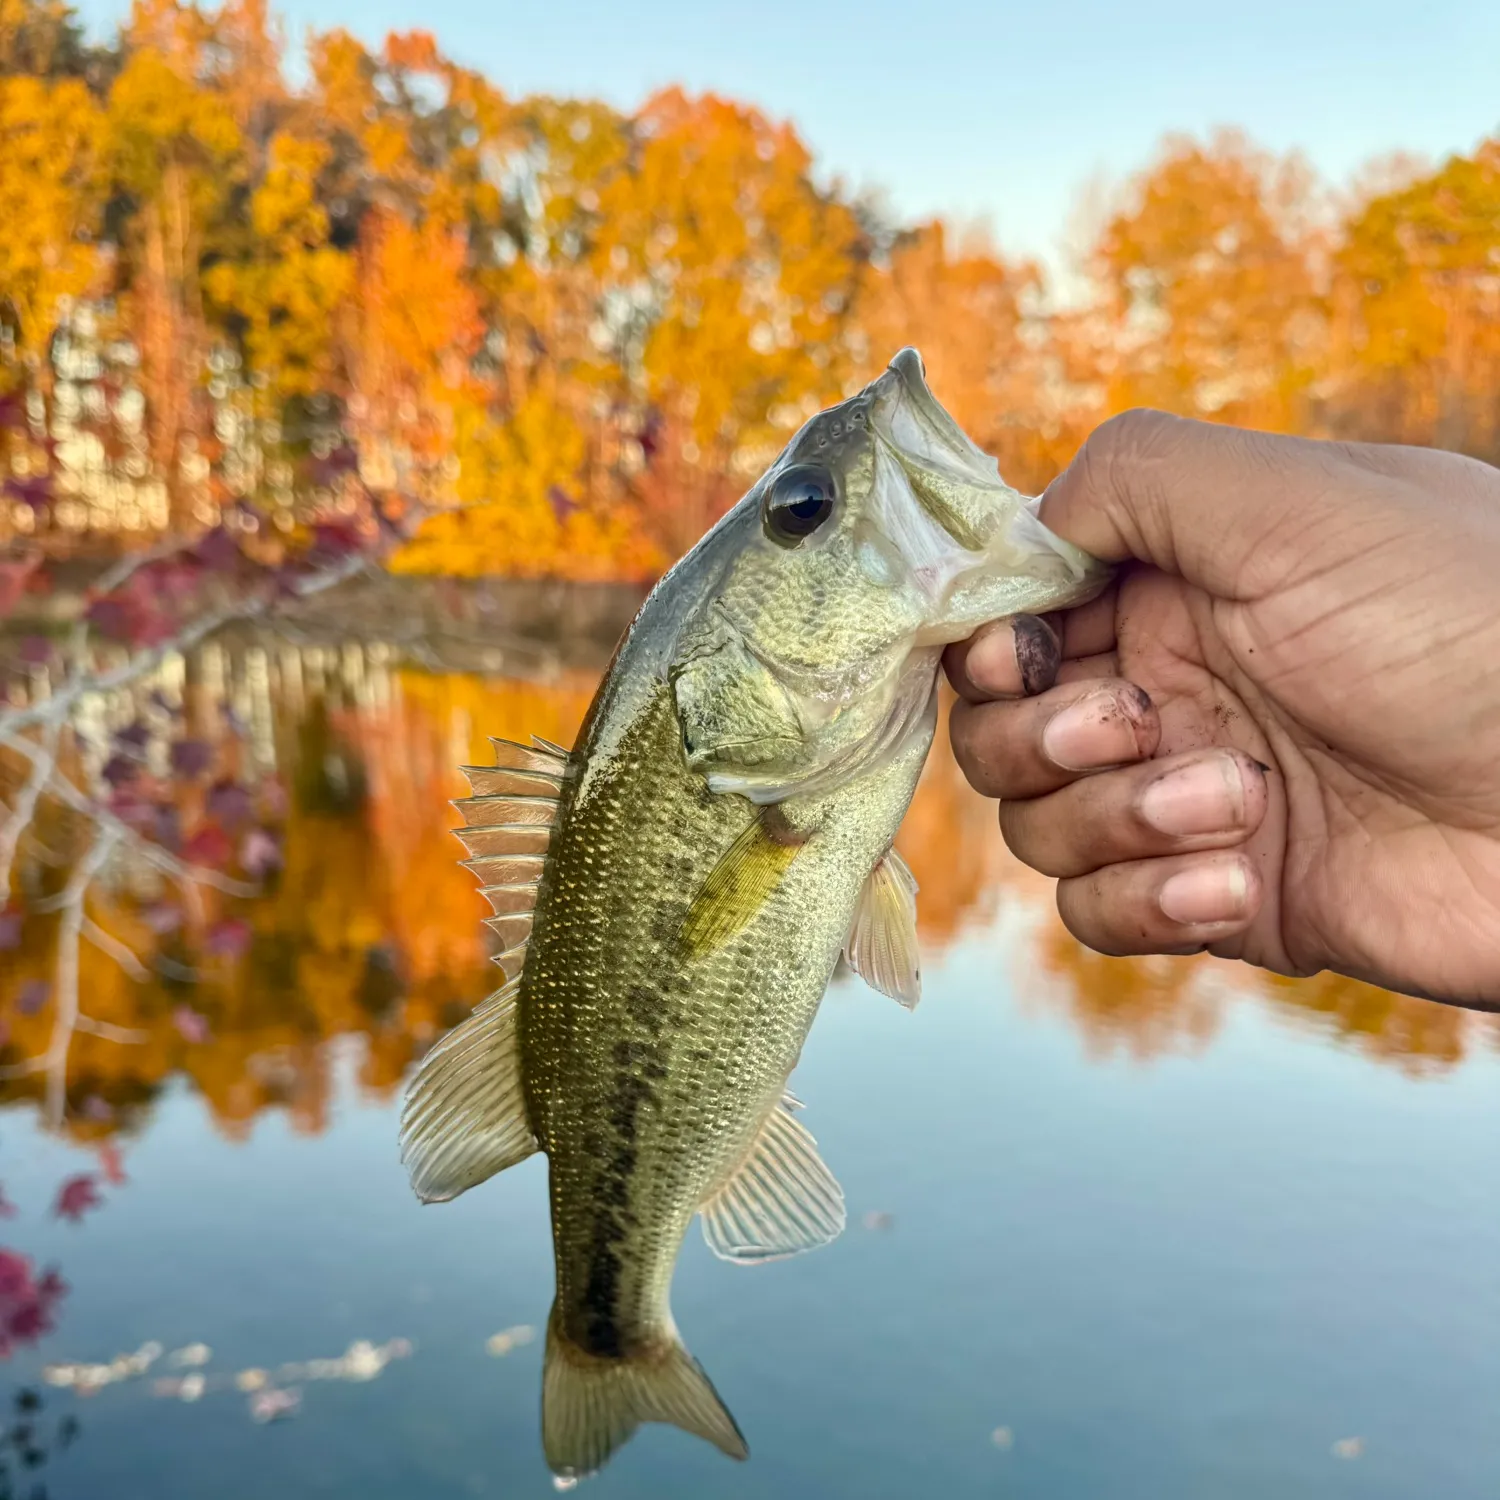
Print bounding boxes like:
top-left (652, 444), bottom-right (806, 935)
top-left (0, 644), bottom-right (1500, 1500)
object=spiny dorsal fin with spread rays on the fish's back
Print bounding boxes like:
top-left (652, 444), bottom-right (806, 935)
top-left (453, 737), bottom-right (570, 980)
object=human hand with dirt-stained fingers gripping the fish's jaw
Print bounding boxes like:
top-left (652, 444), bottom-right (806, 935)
top-left (945, 411), bottom-right (1500, 1010)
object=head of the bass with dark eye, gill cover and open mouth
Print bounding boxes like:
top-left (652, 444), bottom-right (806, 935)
top-left (668, 348), bottom-right (1109, 803)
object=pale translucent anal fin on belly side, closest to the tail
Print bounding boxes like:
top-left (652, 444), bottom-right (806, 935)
top-left (699, 1094), bottom-right (845, 1265)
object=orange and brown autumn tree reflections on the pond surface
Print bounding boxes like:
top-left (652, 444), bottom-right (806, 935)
top-left (0, 641), bottom-right (1500, 1143)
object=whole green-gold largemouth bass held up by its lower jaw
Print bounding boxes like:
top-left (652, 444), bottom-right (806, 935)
top-left (401, 348), bottom-right (1109, 1481)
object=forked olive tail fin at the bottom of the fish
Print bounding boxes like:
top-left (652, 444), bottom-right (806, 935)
top-left (542, 1310), bottom-right (750, 1479)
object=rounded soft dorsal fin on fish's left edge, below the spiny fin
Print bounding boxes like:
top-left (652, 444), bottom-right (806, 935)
top-left (401, 978), bottom-right (537, 1203)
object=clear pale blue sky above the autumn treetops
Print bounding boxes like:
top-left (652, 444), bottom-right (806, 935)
top-left (80, 0), bottom-right (1500, 272)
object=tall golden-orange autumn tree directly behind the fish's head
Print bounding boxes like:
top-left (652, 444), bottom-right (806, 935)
top-left (594, 89), bottom-right (867, 555)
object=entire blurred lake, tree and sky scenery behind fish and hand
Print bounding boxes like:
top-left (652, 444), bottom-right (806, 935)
top-left (0, 0), bottom-right (1500, 1500)
